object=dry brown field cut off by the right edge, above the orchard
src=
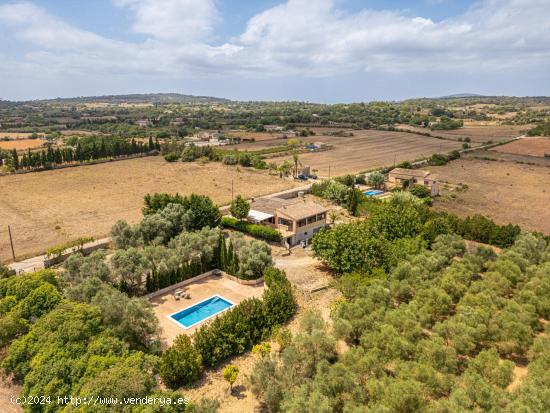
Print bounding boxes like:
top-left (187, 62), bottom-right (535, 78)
top-left (430, 157), bottom-right (550, 234)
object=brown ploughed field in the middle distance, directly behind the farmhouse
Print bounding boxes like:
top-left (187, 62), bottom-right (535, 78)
top-left (269, 130), bottom-right (461, 177)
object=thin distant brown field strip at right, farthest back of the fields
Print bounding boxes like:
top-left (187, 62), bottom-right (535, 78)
top-left (398, 125), bottom-right (530, 143)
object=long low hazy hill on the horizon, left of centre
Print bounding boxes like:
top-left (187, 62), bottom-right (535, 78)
top-left (28, 93), bottom-right (230, 104)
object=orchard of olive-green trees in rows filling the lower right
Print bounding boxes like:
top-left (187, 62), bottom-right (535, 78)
top-left (249, 234), bottom-right (550, 413)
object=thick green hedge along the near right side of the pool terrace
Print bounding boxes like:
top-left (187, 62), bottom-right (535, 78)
top-left (193, 267), bottom-right (296, 366)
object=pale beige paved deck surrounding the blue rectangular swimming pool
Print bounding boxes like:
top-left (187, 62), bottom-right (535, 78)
top-left (150, 276), bottom-right (264, 346)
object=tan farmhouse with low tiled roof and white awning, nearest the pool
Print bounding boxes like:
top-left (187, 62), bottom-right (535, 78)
top-left (248, 197), bottom-right (328, 247)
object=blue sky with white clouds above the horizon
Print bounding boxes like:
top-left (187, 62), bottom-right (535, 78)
top-left (0, 0), bottom-right (550, 103)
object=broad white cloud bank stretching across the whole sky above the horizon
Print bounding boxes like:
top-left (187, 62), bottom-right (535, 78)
top-left (0, 0), bottom-right (550, 91)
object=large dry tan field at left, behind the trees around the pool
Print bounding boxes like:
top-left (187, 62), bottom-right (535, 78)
top-left (0, 156), bottom-right (300, 262)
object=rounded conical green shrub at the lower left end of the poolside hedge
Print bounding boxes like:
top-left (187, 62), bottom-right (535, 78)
top-left (159, 334), bottom-right (202, 389)
